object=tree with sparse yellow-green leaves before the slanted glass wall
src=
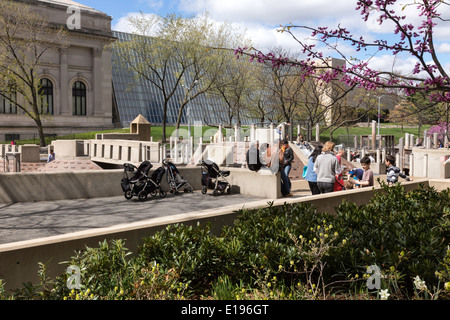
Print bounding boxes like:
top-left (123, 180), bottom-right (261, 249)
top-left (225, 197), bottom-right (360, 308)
top-left (114, 13), bottom-right (246, 142)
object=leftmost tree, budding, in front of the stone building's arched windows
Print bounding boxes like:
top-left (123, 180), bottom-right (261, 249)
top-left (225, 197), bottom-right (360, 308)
top-left (0, 0), bottom-right (67, 146)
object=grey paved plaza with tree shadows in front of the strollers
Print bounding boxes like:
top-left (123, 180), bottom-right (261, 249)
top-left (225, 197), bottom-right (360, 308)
top-left (0, 191), bottom-right (263, 244)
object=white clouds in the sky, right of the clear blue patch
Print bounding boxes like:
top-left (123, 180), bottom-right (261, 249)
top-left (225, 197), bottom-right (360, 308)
top-left (113, 0), bottom-right (450, 73)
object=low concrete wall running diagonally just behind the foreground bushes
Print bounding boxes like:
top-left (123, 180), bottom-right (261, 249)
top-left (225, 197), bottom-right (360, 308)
top-left (0, 177), bottom-right (450, 289)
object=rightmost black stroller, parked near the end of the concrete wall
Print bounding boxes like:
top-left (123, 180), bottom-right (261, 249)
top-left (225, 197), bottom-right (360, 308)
top-left (201, 160), bottom-right (231, 196)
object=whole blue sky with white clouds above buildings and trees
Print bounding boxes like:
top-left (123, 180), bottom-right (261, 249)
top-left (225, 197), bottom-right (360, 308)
top-left (79, 0), bottom-right (450, 77)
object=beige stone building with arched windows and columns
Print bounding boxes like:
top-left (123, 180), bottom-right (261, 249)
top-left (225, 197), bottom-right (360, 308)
top-left (0, 0), bottom-right (115, 141)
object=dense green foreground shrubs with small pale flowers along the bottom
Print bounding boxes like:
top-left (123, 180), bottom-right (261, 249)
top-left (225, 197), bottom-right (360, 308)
top-left (0, 185), bottom-right (450, 300)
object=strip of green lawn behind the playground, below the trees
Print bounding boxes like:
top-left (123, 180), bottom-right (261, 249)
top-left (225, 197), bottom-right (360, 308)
top-left (0, 123), bottom-right (430, 145)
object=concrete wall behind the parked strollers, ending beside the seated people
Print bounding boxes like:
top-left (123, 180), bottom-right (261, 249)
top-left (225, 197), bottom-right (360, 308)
top-left (0, 166), bottom-right (281, 203)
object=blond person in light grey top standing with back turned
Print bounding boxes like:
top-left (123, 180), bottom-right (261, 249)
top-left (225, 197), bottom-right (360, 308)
top-left (314, 141), bottom-right (341, 193)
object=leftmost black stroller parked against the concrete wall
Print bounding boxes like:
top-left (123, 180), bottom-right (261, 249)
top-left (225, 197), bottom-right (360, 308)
top-left (121, 161), bottom-right (166, 201)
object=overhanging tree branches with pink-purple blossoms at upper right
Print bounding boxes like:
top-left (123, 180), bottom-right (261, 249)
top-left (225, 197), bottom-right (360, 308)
top-left (236, 0), bottom-right (450, 106)
